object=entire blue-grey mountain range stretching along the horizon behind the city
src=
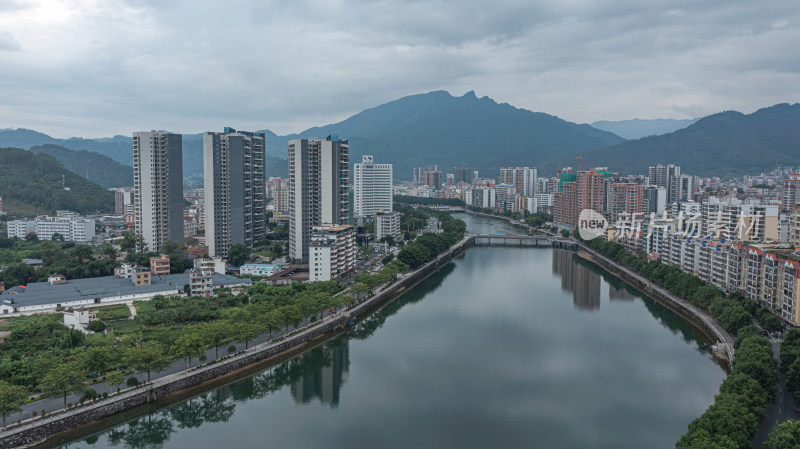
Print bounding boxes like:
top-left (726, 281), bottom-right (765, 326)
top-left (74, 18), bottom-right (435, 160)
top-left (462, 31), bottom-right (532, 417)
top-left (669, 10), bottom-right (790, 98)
top-left (0, 91), bottom-right (800, 185)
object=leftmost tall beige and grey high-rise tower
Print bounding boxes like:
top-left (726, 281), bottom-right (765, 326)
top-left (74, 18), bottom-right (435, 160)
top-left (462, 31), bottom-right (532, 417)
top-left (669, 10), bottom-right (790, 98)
top-left (133, 130), bottom-right (183, 251)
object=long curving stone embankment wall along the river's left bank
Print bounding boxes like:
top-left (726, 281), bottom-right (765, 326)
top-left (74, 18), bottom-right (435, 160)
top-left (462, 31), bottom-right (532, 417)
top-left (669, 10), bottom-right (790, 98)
top-left (0, 236), bottom-right (473, 449)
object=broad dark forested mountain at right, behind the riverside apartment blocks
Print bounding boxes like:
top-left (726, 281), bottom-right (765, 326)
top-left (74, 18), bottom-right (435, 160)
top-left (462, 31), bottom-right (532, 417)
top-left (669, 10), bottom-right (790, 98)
top-left (568, 103), bottom-right (800, 177)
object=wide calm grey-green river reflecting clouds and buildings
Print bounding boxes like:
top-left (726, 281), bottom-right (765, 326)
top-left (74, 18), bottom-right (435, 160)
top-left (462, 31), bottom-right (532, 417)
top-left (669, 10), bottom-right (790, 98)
top-left (42, 214), bottom-right (725, 449)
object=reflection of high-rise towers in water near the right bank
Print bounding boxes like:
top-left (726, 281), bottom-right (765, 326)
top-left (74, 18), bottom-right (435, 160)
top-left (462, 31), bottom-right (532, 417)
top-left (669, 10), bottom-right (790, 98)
top-left (553, 249), bottom-right (600, 310)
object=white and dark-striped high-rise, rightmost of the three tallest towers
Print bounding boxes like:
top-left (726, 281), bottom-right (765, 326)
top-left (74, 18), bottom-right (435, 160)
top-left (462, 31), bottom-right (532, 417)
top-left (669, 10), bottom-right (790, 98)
top-left (289, 135), bottom-right (350, 263)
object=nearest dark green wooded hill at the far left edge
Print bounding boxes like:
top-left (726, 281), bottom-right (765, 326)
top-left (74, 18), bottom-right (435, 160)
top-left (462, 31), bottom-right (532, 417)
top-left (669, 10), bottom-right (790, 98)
top-left (0, 148), bottom-right (114, 216)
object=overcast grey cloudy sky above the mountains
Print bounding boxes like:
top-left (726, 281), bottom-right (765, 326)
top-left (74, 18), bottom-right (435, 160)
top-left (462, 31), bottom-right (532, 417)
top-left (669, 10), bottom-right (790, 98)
top-left (0, 0), bottom-right (800, 137)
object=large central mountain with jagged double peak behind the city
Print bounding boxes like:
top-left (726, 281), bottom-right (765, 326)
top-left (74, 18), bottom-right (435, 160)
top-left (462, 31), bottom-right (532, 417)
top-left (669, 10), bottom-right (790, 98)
top-left (256, 91), bottom-right (624, 180)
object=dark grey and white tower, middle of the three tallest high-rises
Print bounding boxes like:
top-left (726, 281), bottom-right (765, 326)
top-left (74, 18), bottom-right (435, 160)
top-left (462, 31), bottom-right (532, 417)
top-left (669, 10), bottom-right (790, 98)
top-left (203, 127), bottom-right (267, 257)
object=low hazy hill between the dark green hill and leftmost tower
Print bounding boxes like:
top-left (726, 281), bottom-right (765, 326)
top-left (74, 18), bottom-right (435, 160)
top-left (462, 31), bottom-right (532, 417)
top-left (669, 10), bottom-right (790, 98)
top-left (30, 144), bottom-right (133, 187)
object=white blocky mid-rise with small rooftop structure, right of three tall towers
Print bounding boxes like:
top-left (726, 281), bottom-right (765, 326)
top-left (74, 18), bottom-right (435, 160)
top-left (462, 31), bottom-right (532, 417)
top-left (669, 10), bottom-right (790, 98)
top-left (353, 156), bottom-right (392, 217)
